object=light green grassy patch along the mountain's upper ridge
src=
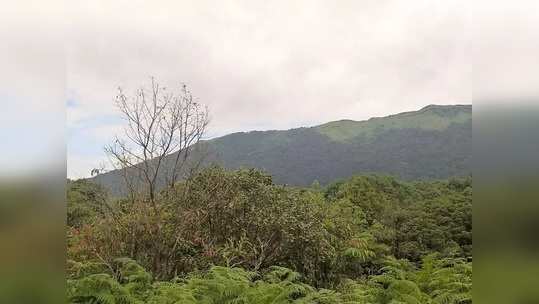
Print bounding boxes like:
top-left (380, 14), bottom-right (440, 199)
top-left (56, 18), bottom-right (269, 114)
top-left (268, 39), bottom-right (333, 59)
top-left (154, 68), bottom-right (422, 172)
top-left (315, 105), bottom-right (472, 142)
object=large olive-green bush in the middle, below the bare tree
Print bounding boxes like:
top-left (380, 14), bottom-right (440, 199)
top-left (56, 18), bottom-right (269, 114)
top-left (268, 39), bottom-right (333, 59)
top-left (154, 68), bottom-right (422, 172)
top-left (73, 167), bottom-right (338, 281)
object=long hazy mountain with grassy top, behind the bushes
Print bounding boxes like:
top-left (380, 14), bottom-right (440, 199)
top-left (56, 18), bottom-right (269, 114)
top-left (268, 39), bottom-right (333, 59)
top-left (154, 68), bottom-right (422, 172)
top-left (93, 105), bottom-right (472, 194)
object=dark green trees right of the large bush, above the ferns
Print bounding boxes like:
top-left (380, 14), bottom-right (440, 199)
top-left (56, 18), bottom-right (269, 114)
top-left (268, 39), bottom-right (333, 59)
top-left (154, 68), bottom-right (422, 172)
top-left (325, 175), bottom-right (472, 262)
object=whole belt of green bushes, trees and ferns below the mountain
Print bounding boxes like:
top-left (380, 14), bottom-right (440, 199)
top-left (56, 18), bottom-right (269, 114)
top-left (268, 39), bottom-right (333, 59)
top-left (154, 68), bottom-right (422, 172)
top-left (67, 166), bottom-right (472, 304)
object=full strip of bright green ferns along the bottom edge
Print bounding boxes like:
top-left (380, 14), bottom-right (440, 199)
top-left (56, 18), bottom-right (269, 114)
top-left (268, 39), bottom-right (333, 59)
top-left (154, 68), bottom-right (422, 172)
top-left (68, 255), bottom-right (471, 304)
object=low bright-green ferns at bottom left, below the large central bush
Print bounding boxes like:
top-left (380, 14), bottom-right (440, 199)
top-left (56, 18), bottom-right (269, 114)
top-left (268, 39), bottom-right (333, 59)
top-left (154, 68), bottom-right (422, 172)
top-left (68, 260), bottom-right (328, 304)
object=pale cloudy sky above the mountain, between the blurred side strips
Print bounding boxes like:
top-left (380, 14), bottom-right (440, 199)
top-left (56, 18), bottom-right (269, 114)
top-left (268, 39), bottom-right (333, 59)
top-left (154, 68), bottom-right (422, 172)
top-left (67, 0), bottom-right (472, 177)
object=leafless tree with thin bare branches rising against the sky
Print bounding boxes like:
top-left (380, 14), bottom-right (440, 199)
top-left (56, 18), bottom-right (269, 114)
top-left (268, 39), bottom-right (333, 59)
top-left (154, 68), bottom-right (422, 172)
top-left (105, 77), bottom-right (209, 207)
